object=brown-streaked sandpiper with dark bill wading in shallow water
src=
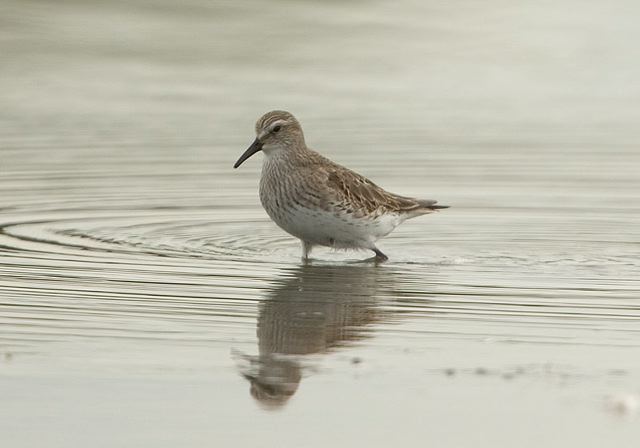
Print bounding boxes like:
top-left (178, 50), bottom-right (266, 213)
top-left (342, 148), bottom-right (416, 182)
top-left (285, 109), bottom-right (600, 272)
top-left (233, 110), bottom-right (448, 261)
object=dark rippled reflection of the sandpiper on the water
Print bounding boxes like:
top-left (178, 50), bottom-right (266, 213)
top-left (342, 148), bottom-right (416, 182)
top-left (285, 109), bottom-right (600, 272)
top-left (241, 265), bottom-right (390, 408)
